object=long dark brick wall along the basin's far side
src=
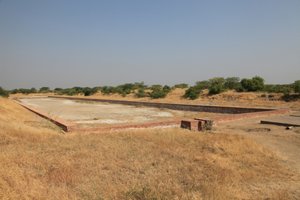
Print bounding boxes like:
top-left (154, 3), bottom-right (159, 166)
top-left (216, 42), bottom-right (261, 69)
top-left (48, 96), bottom-right (275, 114)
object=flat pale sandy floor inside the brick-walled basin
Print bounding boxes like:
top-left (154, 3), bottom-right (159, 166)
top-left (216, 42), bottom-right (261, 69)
top-left (21, 98), bottom-right (225, 124)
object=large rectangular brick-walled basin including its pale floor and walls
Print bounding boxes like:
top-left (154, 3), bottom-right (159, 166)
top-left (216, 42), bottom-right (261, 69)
top-left (18, 96), bottom-right (288, 132)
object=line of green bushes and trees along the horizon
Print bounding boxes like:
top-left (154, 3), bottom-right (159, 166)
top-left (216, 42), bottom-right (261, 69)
top-left (0, 76), bottom-right (300, 100)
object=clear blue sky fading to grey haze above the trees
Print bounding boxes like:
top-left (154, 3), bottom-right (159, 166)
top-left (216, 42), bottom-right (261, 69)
top-left (0, 0), bottom-right (300, 89)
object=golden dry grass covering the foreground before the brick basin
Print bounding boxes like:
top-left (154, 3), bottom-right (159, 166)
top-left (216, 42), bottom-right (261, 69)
top-left (0, 98), bottom-right (300, 199)
